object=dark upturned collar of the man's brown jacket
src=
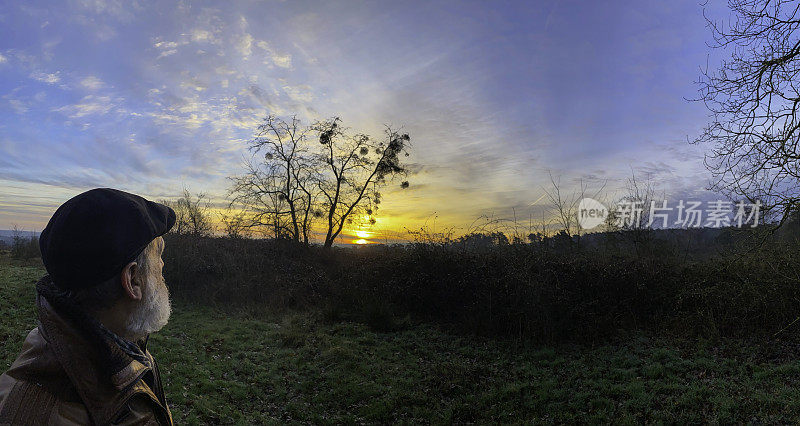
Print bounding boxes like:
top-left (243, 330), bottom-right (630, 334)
top-left (36, 276), bottom-right (154, 424)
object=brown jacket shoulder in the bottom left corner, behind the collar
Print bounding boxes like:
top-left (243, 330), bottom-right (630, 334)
top-left (0, 328), bottom-right (88, 425)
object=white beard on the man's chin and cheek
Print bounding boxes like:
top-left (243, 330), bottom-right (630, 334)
top-left (126, 273), bottom-right (172, 339)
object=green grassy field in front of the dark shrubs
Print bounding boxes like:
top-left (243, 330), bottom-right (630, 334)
top-left (0, 263), bottom-right (800, 424)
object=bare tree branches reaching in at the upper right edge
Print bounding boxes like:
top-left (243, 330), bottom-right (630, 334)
top-left (694, 0), bottom-right (800, 222)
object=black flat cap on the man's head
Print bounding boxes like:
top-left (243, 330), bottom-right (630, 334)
top-left (39, 188), bottom-right (175, 290)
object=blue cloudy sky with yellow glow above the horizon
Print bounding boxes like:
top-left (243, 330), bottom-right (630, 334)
top-left (0, 0), bottom-right (728, 239)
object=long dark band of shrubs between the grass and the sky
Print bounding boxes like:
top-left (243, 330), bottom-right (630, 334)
top-left (164, 235), bottom-right (800, 341)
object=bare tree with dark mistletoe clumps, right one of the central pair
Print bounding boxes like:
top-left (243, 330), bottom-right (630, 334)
top-left (313, 117), bottom-right (411, 247)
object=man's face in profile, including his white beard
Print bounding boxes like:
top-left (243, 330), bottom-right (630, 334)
top-left (127, 237), bottom-right (172, 338)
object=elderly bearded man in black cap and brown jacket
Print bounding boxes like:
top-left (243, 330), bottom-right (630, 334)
top-left (0, 188), bottom-right (175, 425)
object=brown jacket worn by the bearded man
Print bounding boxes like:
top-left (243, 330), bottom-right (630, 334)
top-left (0, 278), bottom-right (172, 425)
